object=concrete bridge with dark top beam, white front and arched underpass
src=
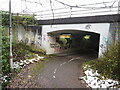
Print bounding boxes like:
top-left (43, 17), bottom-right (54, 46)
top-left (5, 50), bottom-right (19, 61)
top-left (38, 14), bottom-right (120, 56)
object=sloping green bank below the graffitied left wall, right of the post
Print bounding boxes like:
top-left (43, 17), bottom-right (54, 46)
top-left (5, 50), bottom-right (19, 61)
top-left (13, 42), bottom-right (45, 61)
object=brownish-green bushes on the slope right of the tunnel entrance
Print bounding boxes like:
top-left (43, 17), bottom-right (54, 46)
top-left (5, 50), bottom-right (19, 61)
top-left (85, 42), bottom-right (120, 81)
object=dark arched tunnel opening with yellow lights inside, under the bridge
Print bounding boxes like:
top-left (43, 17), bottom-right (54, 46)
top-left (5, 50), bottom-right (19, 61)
top-left (48, 30), bottom-right (100, 56)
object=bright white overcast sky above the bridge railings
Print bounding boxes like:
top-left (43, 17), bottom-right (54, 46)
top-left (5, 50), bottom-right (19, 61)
top-left (0, 0), bottom-right (119, 19)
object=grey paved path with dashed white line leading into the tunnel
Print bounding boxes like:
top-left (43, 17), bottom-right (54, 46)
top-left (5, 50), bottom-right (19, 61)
top-left (35, 55), bottom-right (96, 88)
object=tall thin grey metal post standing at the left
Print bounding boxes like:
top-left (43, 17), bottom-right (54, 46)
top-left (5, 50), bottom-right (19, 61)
top-left (9, 0), bottom-right (13, 71)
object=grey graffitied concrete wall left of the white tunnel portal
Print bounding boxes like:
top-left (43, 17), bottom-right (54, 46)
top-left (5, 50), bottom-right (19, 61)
top-left (13, 25), bottom-right (42, 48)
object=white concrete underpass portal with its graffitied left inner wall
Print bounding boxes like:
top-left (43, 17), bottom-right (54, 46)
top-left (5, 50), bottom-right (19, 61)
top-left (42, 23), bottom-right (110, 56)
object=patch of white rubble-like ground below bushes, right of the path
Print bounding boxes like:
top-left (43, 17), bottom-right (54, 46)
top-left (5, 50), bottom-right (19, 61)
top-left (81, 67), bottom-right (118, 88)
